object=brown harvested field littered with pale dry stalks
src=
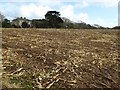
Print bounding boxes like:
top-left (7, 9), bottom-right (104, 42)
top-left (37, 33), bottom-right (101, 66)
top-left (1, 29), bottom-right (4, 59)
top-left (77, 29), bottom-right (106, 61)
top-left (2, 29), bottom-right (120, 89)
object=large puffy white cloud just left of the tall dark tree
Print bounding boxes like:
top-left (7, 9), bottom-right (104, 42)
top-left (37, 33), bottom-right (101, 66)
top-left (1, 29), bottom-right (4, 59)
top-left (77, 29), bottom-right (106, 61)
top-left (20, 4), bottom-right (52, 18)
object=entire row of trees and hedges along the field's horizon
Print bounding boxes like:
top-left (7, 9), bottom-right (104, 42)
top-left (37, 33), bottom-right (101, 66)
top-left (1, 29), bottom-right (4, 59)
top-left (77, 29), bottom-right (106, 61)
top-left (0, 11), bottom-right (118, 29)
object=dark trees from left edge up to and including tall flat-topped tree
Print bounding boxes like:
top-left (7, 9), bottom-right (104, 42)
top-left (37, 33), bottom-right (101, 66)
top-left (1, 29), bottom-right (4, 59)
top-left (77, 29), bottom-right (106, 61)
top-left (1, 11), bottom-right (63, 28)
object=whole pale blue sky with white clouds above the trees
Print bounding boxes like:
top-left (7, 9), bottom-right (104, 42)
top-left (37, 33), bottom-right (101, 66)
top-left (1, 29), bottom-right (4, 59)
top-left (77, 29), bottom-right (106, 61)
top-left (0, 0), bottom-right (119, 27)
